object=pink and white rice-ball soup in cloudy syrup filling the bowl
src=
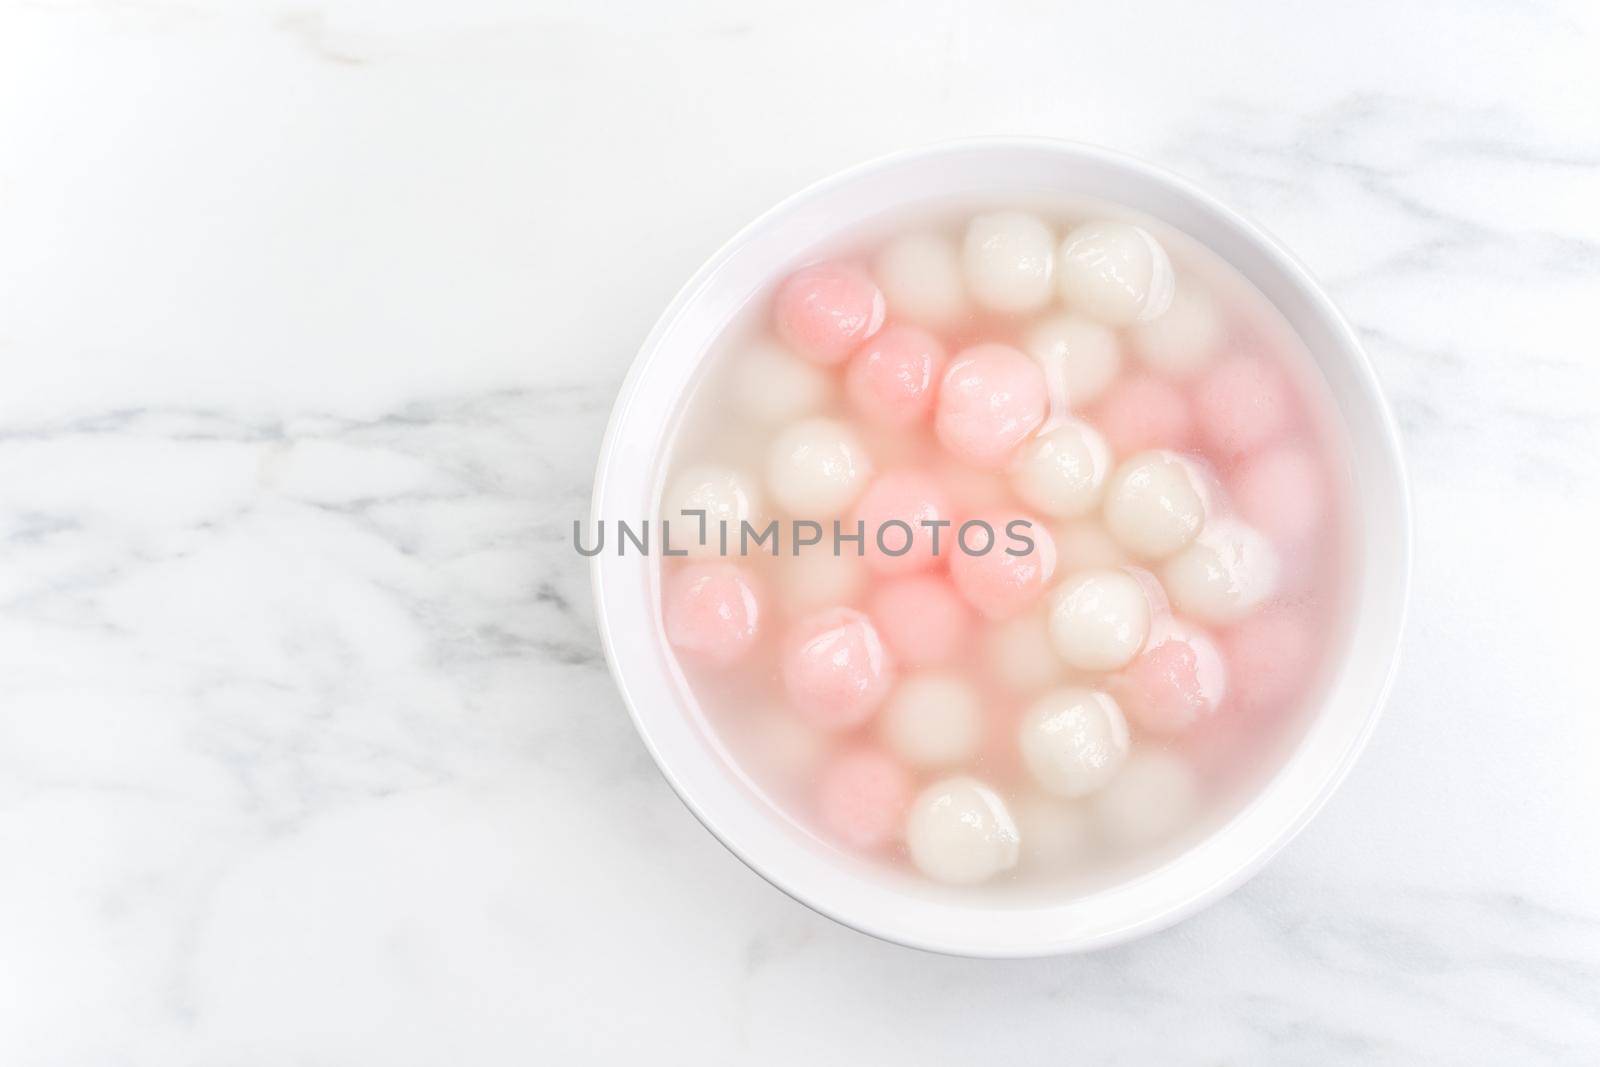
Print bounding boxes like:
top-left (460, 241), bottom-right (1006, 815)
top-left (659, 197), bottom-right (1357, 902)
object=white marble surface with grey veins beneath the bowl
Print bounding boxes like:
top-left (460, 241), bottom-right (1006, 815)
top-left (0, 0), bottom-right (1600, 1067)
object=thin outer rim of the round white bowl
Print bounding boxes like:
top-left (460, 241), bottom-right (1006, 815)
top-left (589, 136), bottom-right (1414, 958)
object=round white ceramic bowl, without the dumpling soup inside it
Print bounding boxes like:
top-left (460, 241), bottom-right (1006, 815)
top-left (594, 139), bottom-right (1411, 957)
